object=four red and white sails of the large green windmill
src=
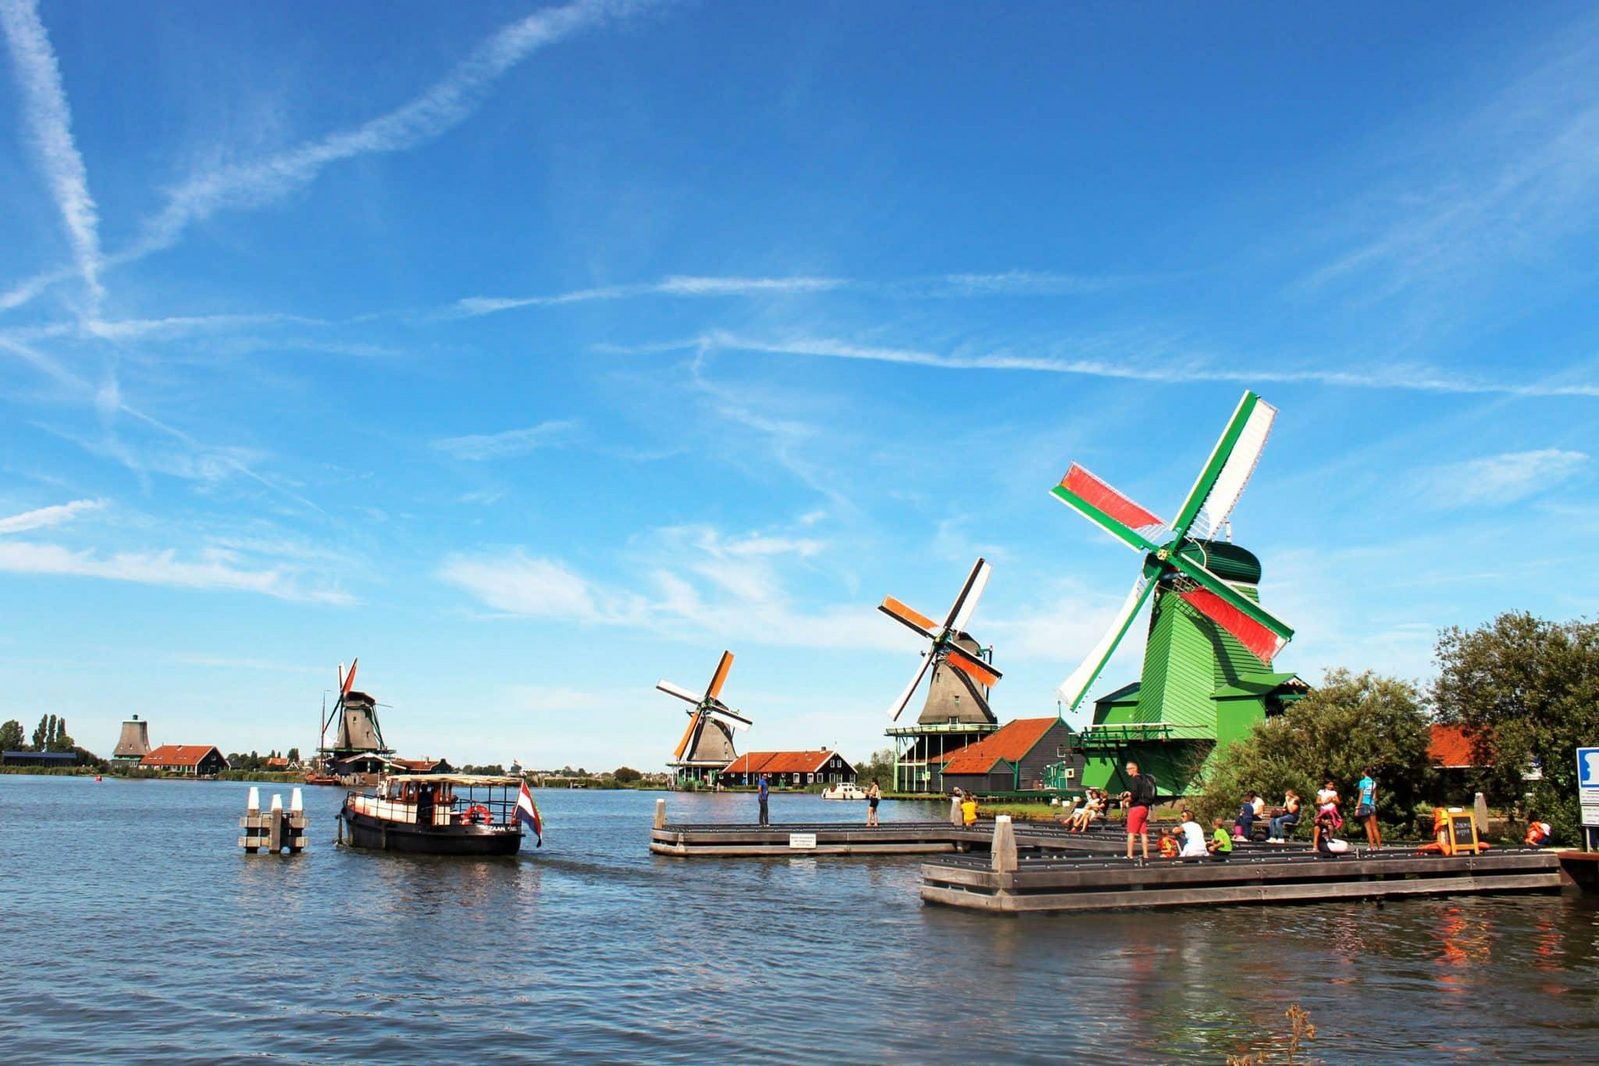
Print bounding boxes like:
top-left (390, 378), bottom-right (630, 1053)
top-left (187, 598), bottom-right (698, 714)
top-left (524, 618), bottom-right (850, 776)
top-left (1052, 392), bottom-right (1294, 711)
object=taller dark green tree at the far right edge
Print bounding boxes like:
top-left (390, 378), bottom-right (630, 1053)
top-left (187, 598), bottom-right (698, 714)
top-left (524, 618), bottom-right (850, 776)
top-left (1433, 612), bottom-right (1599, 842)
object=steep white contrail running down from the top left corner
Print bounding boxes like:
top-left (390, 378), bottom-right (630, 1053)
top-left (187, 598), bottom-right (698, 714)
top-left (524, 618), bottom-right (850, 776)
top-left (0, 0), bottom-right (104, 305)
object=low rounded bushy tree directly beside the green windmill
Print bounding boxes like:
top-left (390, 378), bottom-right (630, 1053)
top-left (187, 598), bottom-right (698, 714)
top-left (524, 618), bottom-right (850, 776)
top-left (1194, 668), bottom-right (1434, 831)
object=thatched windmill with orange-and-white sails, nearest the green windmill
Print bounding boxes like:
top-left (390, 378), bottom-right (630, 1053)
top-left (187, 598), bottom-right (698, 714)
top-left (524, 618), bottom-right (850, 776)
top-left (878, 559), bottom-right (999, 793)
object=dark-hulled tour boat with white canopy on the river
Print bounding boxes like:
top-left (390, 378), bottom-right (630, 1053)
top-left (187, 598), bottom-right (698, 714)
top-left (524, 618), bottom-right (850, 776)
top-left (339, 774), bottom-right (542, 855)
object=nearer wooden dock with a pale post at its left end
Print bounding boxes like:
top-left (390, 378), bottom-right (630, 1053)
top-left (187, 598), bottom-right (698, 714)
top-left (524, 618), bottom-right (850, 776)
top-left (921, 849), bottom-right (1562, 914)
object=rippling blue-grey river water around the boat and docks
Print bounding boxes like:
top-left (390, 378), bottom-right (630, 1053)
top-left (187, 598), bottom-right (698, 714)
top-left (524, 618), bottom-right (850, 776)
top-left (0, 777), bottom-right (1599, 1063)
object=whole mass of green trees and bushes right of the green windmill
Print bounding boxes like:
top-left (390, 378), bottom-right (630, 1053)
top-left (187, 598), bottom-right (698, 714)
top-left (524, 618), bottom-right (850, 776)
top-left (1194, 612), bottom-right (1599, 844)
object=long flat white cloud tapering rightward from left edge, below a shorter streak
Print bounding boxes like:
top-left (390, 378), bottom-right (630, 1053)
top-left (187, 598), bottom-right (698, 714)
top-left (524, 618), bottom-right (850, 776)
top-left (0, 540), bottom-right (353, 604)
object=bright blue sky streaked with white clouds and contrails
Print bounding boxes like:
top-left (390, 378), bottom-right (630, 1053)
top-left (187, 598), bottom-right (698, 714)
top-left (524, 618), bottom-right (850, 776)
top-left (0, 0), bottom-right (1599, 767)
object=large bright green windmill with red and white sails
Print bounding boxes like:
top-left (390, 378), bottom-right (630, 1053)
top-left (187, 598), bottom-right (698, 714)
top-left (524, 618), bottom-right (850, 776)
top-left (1052, 392), bottom-right (1306, 794)
